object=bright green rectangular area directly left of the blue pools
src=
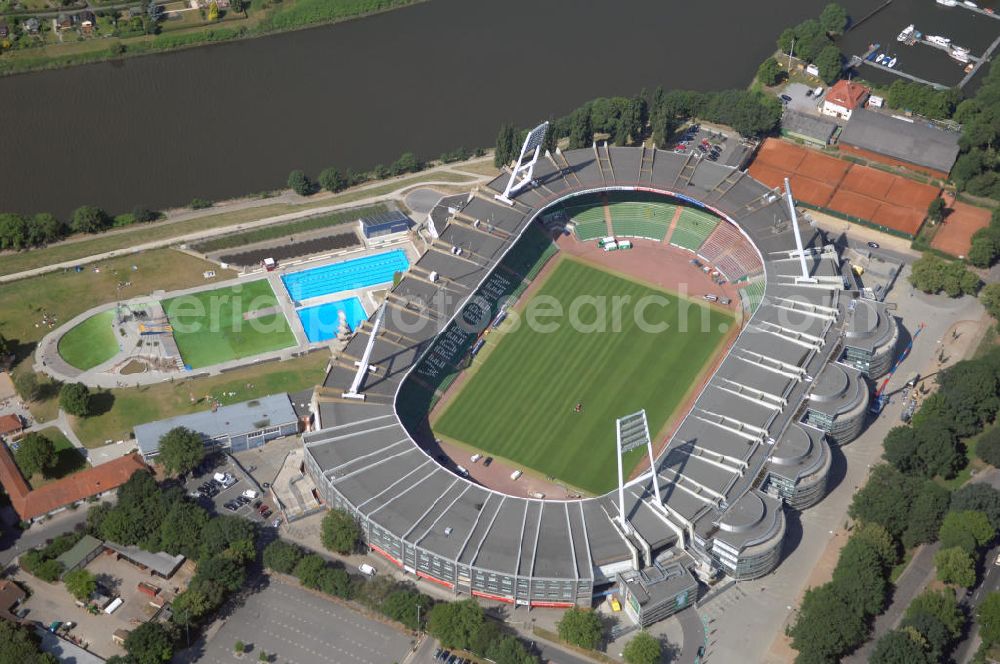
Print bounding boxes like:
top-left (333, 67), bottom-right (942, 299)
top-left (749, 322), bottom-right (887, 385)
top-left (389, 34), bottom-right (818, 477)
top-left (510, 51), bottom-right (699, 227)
top-left (162, 279), bottom-right (295, 369)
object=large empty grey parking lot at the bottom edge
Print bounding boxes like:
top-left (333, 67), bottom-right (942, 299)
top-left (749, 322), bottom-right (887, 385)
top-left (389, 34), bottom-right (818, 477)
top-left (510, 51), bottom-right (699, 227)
top-left (192, 579), bottom-right (413, 664)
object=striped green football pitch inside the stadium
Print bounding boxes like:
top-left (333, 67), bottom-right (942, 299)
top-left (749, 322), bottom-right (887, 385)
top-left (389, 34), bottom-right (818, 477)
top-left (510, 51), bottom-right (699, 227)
top-left (433, 260), bottom-right (733, 494)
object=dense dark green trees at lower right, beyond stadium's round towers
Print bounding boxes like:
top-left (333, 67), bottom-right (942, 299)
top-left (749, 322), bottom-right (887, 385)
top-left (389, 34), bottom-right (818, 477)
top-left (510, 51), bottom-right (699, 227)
top-left (788, 350), bottom-right (1000, 664)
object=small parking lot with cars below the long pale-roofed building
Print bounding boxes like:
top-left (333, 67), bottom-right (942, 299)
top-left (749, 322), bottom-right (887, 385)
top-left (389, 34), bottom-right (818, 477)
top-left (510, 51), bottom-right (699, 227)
top-left (184, 452), bottom-right (277, 524)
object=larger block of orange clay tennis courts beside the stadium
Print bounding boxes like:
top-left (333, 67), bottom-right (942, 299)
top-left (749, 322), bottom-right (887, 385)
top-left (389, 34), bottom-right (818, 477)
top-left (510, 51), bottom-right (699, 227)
top-left (750, 138), bottom-right (941, 238)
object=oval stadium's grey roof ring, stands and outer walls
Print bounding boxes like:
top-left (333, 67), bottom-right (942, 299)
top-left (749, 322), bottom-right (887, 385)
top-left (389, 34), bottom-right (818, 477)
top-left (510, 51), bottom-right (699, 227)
top-left (303, 145), bottom-right (898, 617)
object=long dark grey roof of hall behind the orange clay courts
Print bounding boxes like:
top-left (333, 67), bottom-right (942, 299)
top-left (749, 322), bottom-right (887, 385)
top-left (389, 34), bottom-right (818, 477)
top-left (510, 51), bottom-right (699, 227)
top-left (840, 109), bottom-right (959, 173)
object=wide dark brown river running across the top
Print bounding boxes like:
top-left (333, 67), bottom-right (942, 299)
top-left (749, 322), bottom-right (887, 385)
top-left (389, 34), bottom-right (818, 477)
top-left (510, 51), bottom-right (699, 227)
top-left (0, 0), bottom-right (1000, 215)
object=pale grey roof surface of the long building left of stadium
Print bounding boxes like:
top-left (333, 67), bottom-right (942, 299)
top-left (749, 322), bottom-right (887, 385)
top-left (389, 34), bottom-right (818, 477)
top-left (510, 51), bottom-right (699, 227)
top-left (135, 394), bottom-right (298, 456)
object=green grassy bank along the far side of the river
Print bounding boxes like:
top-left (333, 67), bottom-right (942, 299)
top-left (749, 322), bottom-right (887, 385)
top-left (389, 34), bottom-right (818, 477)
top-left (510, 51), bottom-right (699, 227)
top-left (0, 0), bottom-right (422, 75)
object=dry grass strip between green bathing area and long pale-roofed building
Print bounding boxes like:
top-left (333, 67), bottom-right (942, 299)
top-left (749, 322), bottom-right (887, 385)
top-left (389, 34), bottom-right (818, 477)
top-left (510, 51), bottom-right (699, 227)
top-left (73, 352), bottom-right (330, 447)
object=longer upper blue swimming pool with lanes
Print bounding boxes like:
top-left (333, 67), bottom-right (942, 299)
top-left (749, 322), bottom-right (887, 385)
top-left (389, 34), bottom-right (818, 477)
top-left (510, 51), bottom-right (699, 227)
top-left (281, 249), bottom-right (410, 302)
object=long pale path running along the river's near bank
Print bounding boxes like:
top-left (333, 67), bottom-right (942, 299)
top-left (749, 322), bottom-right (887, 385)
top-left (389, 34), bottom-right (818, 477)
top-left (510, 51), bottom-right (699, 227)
top-left (0, 158), bottom-right (493, 283)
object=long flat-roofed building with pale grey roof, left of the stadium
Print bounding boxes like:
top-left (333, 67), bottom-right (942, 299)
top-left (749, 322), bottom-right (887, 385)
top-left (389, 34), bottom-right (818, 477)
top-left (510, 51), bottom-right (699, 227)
top-left (135, 394), bottom-right (299, 459)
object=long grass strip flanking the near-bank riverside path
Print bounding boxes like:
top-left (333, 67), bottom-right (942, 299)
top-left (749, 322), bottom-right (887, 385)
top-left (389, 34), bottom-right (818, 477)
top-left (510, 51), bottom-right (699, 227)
top-left (0, 172), bottom-right (472, 280)
